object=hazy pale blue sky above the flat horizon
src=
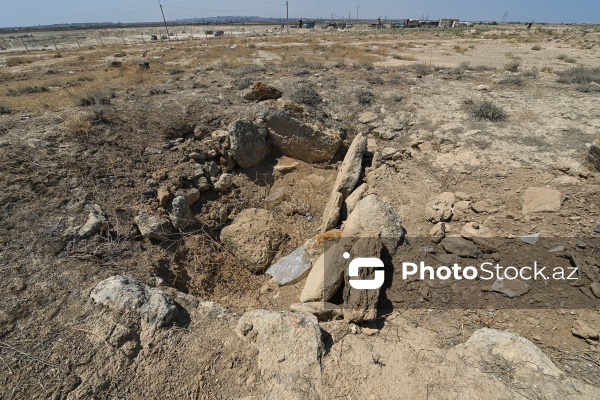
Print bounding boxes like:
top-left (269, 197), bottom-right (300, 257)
top-left (0, 0), bottom-right (600, 27)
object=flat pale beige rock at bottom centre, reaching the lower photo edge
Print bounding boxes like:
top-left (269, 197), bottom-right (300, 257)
top-left (235, 310), bottom-right (322, 400)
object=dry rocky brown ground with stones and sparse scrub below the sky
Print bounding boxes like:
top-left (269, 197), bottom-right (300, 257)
top-left (0, 25), bottom-right (600, 399)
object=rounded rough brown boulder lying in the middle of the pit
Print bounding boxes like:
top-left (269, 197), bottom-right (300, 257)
top-left (221, 208), bottom-right (284, 272)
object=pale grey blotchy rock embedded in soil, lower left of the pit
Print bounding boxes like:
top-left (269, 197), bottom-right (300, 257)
top-left (90, 275), bottom-right (178, 327)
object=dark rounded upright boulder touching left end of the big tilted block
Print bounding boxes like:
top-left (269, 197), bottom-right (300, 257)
top-left (229, 120), bottom-right (267, 169)
